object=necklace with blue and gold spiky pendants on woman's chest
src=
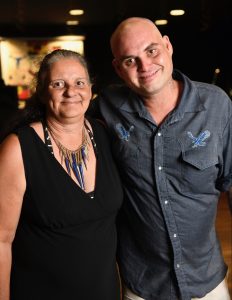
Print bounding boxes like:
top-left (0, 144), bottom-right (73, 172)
top-left (43, 122), bottom-right (97, 190)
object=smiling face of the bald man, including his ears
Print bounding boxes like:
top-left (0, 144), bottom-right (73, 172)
top-left (112, 22), bottom-right (173, 98)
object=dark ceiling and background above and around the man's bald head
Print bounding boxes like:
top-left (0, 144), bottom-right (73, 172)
top-left (0, 0), bottom-right (232, 96)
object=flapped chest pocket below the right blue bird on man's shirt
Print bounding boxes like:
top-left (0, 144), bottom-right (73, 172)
top-left (178, 132), bottom-right (219, 194)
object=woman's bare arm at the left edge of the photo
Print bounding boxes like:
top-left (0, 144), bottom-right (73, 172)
top-left (0, 134), bottom-right (26, 300)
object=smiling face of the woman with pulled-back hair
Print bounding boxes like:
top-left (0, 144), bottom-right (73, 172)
top-left (47, 58), bottom-right (92, 121)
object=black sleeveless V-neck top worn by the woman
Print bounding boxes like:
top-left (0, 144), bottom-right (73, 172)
top-left (10, 121), bottom-right (122, 300)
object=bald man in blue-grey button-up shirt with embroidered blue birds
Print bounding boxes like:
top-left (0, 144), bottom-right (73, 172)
top-left (88, 18), bottom-right (232, 300)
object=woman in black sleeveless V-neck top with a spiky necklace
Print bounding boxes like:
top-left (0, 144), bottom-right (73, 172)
top-left (0, 50), bottom-right (122, 300)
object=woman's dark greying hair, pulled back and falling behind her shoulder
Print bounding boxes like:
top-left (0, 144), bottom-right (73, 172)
top-left (17, 49), bottom-right (90, 127)
